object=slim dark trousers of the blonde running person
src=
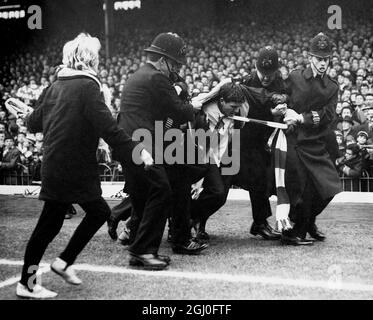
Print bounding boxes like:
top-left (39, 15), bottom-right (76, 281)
top-left (21, 197), bottom-right (110, 287)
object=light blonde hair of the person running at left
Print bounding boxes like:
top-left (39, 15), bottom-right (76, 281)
top-left (62, 33), bottom-right (101, 70)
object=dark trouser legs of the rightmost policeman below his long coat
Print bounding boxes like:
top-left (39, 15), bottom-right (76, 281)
top-left (290, 177), bottom-right (333, 238)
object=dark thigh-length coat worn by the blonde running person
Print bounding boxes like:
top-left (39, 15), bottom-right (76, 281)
top-left (27, 75), bottom-right (137, 203)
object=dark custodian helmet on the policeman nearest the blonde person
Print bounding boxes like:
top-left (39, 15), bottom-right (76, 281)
top-left (145, 32), bottom-right (186, 64)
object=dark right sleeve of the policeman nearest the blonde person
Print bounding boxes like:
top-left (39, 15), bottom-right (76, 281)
top-left (152, 74), bottom-right (194, 124)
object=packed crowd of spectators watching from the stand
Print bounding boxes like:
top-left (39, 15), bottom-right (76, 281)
top-left (0, 1), bottom-right (373, 183)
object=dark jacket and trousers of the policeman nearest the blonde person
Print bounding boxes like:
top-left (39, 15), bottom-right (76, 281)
top-left (119, 64), bottom-right (193, 254)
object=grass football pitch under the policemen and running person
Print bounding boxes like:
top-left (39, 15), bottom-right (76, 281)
top-left (0, 196), bottom-right (373, 300)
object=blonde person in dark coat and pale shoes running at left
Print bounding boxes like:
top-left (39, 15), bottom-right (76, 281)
top-left (16, 34), bottom-right (153, 298)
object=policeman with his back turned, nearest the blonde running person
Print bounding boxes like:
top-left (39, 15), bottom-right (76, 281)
top-left (118, 32), bottom-right (204, 270)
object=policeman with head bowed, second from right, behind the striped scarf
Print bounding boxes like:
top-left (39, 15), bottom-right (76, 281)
top-left (235, 46), bottom-right (286, 240)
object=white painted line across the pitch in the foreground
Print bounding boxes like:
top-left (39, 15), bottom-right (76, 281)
top-left (0, 259), bottom-right (373, 292)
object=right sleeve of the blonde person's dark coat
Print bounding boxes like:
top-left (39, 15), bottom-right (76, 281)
top-left (83, 81), bottom-right (144, 162)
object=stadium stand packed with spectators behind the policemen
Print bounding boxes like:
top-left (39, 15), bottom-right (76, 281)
top-left (0, 1), bottom-right (373, 191)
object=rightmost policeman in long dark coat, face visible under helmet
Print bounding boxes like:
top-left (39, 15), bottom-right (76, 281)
top-left (282, 33), bottom-right (341, 245)
